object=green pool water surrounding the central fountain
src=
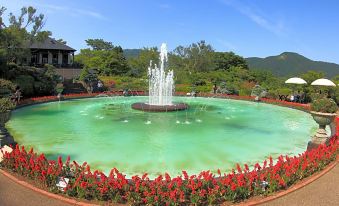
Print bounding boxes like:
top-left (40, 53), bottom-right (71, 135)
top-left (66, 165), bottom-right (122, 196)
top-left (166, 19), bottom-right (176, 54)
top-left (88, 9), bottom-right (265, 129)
top-left (6, 97), bottom-right (316, 177)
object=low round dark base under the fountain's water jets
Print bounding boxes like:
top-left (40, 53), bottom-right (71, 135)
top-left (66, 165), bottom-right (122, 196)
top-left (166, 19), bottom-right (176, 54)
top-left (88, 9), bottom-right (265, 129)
top-left (132, 102), bottom-right (188, 112)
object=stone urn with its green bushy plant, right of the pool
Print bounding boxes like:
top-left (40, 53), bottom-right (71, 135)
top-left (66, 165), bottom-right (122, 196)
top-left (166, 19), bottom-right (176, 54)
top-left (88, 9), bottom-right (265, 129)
top-left (308, 98), bottom-right (338, 149)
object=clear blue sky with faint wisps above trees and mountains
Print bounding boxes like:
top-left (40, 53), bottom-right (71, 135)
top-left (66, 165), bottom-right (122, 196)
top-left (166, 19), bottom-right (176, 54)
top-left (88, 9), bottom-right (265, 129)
top-left (0, 0), bottom-right (339, 63)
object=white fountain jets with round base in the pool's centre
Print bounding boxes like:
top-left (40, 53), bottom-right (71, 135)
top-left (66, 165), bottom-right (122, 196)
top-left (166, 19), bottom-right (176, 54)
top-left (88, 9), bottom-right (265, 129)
top-left (132, 43), bottom-right (188, 112)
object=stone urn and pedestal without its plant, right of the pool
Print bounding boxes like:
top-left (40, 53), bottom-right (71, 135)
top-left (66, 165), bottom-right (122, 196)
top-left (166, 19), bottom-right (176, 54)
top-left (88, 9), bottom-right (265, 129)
top-left (307, 111), bottom-right (337, 150)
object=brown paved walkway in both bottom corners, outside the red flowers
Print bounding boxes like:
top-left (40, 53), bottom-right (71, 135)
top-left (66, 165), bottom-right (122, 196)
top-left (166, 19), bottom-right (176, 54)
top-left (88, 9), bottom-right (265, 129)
top-left (0, 165), bottom-right (339, 206)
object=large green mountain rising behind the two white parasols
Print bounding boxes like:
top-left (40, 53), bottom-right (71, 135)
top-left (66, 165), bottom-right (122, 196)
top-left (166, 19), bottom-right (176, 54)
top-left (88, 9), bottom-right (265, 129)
top-left (246, 52), bottom-right (339, 78)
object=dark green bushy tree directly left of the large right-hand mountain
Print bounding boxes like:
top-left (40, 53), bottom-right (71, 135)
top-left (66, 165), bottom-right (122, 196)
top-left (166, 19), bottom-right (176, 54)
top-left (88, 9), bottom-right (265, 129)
top-left (213, 52), bottom-right (248, 70)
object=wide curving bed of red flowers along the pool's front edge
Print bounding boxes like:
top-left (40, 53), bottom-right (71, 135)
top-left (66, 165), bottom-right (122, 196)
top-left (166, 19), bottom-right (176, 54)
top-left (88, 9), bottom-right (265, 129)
top-left (1, 137), bottom-right (339, 205)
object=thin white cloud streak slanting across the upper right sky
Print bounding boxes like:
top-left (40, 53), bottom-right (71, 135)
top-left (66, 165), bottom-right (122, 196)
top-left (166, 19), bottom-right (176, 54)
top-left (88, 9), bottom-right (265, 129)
top-left (221, 0), bottom-right (287, 36)
